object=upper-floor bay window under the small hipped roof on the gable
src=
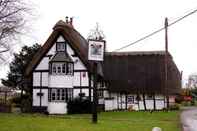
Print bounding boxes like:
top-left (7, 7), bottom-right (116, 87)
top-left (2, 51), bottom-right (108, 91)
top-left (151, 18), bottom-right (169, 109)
top-left (51, 62), bottom-right (74, 75)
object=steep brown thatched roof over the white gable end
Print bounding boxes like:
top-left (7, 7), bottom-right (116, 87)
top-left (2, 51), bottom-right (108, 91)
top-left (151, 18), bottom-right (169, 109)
top-left (25, 20), bottom-right (92, 76)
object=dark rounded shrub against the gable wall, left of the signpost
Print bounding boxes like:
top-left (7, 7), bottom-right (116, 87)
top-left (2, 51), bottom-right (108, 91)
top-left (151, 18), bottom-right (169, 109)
top-left (67, 98), bottom-right (92, 114)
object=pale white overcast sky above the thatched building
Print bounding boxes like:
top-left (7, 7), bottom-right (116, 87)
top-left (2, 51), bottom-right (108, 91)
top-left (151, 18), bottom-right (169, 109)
top-left (0, 0), bottom-right (197, 83)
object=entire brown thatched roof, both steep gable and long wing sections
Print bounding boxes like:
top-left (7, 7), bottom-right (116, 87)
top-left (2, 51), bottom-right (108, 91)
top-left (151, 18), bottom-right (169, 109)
top-left (25, 21), bottom-right (181, 93)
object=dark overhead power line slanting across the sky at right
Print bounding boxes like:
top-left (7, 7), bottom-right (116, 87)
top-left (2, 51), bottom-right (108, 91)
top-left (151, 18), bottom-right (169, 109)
top-left (112, 9), bottom-right (197, 52)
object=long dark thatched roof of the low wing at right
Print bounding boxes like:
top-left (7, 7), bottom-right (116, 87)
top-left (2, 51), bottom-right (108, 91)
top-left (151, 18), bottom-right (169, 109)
top-left (103, 51), bottom-right (181, 94)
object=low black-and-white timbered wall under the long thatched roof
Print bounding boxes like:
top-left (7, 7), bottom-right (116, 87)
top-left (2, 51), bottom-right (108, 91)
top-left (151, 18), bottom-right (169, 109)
top-left (104, 93), bottom-right (169, 111)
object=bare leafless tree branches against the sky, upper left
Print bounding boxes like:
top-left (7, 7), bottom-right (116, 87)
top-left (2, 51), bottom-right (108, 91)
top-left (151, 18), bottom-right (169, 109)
top-left (0, 0), bottom-right (31, 64)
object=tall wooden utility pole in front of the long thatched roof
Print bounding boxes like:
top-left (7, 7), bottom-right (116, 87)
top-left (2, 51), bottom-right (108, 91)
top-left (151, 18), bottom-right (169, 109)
top-left (164, 18), bottom-right (169, 109)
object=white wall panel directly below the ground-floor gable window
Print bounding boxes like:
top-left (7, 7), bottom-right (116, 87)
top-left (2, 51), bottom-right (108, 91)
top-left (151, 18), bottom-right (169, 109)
top-left (47, 102), bottom-right (67, 114)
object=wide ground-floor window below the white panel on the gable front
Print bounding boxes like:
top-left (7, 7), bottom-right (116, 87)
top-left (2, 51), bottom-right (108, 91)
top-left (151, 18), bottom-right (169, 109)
top-left (49, 88), bottom-right (73, 102)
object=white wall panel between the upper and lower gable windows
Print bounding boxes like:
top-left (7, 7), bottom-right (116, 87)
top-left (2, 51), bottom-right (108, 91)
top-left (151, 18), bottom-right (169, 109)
top-left (49, 75), bottom-right (73, 88)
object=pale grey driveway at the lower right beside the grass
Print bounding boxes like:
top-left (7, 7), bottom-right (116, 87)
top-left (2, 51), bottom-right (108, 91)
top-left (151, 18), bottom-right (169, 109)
top-left (181, 107), bottom-right (197, 131)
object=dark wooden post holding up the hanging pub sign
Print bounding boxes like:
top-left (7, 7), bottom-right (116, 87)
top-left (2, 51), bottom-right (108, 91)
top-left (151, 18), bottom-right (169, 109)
top-left (92, 62), bottom-right (98, 123)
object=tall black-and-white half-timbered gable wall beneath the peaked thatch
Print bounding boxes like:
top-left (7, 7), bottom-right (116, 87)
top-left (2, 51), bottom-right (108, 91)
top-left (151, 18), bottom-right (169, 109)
top-left (33, 36), bottom-right (89, 114)
